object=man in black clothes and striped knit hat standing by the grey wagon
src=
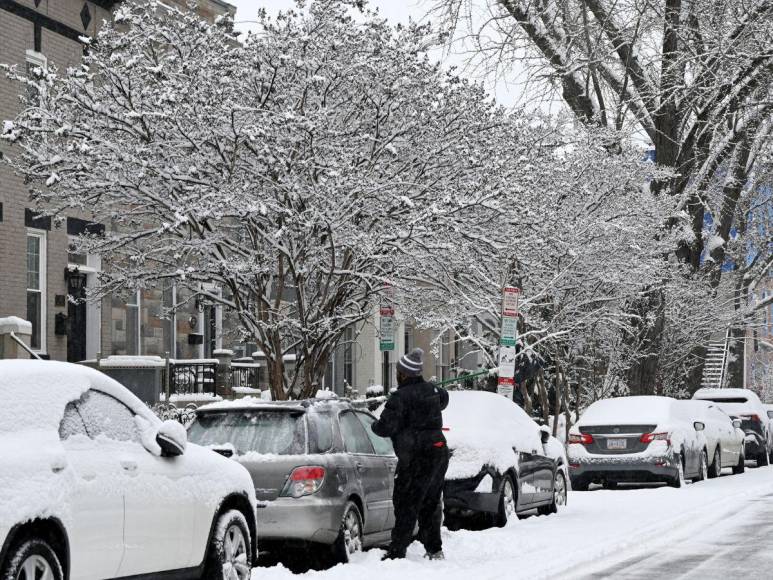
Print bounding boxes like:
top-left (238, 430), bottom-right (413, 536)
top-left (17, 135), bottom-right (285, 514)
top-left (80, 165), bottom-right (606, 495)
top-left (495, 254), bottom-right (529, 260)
top-left (373, 348), bottom-right (448, 560)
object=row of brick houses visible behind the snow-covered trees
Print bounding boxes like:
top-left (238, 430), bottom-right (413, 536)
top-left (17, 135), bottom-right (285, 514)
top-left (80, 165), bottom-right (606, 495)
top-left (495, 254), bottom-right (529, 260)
top-left (0, 0), bottom-right (477, 392)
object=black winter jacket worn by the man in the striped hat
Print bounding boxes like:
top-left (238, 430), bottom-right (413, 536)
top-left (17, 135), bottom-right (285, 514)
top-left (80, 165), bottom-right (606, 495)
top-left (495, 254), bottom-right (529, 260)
top-left (373, 377), bottom-right (448, 460)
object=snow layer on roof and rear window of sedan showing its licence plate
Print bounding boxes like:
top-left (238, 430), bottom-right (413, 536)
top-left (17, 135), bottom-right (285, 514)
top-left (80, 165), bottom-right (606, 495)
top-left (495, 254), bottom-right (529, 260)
top-left (577, 396), bottom-right (674, 427)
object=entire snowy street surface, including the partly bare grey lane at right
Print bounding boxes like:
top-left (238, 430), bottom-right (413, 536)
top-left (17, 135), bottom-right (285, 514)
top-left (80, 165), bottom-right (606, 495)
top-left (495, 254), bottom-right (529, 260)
top-left (253, 467), bottom-right (773, 580)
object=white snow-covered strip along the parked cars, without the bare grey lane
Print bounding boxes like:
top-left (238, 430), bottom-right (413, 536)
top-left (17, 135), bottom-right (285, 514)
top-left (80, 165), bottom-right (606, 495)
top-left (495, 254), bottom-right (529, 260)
top-left (253, 467), bottom-right (773, 580)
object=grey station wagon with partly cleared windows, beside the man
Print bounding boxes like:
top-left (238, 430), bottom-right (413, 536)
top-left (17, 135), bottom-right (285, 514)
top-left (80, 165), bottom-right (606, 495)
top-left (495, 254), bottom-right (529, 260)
top-left (188, 398), bottom-right (397, 561)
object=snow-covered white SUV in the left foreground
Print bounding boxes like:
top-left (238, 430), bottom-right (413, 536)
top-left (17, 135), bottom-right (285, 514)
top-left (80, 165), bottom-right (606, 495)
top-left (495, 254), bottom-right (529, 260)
top-left (0, 361), bottom-right (257, 580)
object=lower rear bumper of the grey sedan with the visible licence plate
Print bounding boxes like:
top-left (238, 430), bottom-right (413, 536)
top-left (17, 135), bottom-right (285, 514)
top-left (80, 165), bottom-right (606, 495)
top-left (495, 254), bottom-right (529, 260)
top-left (569, 456), bottom-right (679, 486)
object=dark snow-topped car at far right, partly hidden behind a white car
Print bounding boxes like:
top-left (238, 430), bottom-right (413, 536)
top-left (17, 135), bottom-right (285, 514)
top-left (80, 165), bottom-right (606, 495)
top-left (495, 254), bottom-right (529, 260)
top-left (693, 389), bottom-right (773, 467)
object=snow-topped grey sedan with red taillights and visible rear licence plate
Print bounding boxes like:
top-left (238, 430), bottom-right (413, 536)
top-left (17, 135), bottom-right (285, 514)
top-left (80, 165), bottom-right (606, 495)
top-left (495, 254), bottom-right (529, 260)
top-left (567, 396), bottom-right (706, 490)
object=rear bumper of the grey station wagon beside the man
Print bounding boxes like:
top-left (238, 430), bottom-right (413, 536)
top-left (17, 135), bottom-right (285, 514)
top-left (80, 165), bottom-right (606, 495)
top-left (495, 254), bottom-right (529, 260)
top-left (258, 496), bottom-right (344, 544)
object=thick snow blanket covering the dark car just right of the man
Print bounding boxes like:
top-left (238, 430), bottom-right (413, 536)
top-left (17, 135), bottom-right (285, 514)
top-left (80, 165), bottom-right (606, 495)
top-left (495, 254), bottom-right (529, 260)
top-left (443, 391), bottom-right (542, 479)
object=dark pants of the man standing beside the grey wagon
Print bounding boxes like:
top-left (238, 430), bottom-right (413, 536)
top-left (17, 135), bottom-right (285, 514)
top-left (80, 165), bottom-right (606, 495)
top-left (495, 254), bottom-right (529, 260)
top-left (389, 446), bottom-right (448, 556)
